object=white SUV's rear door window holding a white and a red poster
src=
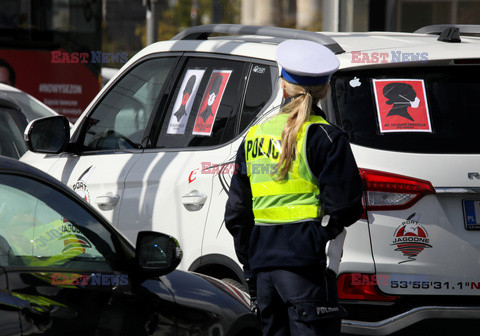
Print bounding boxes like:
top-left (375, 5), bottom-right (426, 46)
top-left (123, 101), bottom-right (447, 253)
top-left (156, 57), bottom-right (247, 148)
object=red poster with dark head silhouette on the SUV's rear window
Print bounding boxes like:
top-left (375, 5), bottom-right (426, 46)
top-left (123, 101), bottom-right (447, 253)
top-left (373, 79), bottom-right (432, 133)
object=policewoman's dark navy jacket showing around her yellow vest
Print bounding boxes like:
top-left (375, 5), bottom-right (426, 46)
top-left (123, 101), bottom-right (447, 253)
top-left (225, 106), bottom-right (362, 278)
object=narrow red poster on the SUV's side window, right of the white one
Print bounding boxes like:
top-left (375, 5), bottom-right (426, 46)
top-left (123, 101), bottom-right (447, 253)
top-left (192, 70), bottom-right (232, 136)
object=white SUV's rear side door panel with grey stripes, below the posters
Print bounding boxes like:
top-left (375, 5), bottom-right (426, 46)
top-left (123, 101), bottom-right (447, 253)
top-left (117, 145), bottom-right (234, 270)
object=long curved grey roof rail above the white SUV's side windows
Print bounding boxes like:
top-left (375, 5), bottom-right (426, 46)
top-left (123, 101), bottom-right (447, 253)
top-left (172, 24), bottom-right (345, 54)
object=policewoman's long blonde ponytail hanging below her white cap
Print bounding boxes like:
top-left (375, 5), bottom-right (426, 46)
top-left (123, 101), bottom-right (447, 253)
top-left (276, 81), bottom-right (329, 180)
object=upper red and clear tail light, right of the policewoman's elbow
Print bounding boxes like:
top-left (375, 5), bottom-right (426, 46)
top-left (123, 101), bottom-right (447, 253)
top-left (360, 169), bottom-right (435, 211)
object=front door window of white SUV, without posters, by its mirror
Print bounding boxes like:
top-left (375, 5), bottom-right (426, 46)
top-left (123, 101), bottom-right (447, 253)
top-left (83, 57), bottom-right (178, 151)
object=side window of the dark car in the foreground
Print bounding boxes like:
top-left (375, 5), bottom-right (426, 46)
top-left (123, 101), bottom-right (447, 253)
top-left (0, 174), bottom-right (120, 271)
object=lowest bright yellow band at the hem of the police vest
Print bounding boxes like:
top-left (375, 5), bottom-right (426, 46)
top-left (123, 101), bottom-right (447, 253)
top-left (253, 205), bottom-right (319, 223)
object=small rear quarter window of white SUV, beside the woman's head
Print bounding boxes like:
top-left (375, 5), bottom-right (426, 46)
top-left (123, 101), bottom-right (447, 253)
top-left (239, 63), bottom-right (278, 133)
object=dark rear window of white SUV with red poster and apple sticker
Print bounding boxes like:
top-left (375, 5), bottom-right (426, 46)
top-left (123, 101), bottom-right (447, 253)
top-left (331, 66), bottom-right (480, 154)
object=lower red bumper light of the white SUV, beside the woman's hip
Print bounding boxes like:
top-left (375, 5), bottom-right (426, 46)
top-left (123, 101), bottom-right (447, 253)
top-left (337, 273), bottom-right (400, 302)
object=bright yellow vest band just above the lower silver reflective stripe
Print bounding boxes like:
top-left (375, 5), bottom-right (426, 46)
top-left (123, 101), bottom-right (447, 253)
top-left (251, 180), bottom-right (318, 198)
